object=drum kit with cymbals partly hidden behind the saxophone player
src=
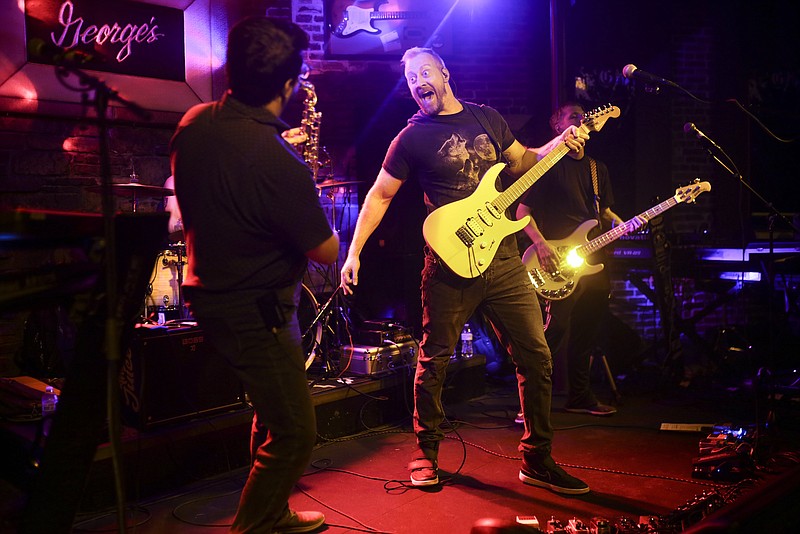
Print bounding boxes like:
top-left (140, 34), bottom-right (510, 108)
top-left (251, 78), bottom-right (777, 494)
top-left (88, 176), bottom-right (361, 369)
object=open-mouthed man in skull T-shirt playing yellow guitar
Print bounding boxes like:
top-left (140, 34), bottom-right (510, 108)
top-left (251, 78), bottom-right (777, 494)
top-left (341, 48), bottom-right (589, 495)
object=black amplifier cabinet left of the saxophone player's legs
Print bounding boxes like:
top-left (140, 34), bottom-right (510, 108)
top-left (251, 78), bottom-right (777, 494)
top-left (120, 327), bottom-right (245, 430)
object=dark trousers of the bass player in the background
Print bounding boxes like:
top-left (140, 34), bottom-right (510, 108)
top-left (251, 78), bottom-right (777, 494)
top-left (545, 272), bottom-right (609, 407)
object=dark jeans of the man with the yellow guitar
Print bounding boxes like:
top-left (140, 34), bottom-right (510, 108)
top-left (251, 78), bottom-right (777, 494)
top-left (414, 254), bottom-right (553, 459)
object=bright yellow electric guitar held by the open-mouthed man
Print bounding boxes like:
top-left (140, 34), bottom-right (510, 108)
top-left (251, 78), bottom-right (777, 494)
top-left (422, 104), bottom-right (620, 278)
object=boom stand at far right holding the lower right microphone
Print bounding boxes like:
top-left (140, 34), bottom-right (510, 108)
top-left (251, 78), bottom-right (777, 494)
top-left (706, 143), bottom-right (800, 466)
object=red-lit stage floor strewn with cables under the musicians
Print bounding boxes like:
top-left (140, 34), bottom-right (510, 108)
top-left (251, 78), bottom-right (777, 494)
top-left (69, 368), bottom-right (799, 534)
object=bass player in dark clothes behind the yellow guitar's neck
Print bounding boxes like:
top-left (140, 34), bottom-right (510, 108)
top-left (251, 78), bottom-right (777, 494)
top-left (517, 102), bottom-right (644, 416)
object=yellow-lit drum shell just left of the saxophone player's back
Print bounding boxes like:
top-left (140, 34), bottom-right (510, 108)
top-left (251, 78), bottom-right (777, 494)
top-left (145, 243), bottom-right (188, 324)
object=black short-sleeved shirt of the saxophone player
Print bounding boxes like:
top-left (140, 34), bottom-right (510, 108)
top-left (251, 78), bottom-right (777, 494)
top-left (171, 95), bottom-right (332, 310)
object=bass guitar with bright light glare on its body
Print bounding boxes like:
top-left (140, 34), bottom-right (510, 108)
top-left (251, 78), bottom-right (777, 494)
top-left (522, 180), bottom-right (711, 300)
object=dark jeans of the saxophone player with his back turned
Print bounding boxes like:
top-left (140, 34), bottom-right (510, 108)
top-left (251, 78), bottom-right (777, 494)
top-left (187, 285), bottom-right (317, 532)
